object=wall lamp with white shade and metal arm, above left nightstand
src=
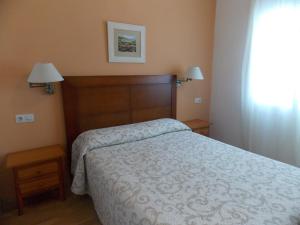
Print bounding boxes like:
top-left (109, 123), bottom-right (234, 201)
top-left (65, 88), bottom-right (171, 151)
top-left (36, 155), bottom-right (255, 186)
top-left (27, 63), bottom-right (64, 95)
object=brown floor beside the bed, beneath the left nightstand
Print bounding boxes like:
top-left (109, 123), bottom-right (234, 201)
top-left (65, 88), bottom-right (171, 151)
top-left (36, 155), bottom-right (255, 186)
top-left (0, 195), bottom-right (101, 225)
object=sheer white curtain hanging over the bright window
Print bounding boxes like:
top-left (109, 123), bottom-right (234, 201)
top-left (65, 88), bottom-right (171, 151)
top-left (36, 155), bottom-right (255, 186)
top-left (242, 0), bottom-right (300, 166)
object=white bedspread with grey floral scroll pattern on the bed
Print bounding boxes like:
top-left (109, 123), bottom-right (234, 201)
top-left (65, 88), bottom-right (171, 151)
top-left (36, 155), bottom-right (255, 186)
top-left (72, 119), bottom-right (300, 225)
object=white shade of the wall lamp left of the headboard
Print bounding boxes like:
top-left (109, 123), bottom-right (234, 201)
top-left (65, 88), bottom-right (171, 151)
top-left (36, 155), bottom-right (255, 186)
top-left (27, 63), bottom-right (64, 83)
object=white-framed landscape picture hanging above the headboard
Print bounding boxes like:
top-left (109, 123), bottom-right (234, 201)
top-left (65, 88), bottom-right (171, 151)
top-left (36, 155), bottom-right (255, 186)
top-left (107, 21), bottom-right (146, 63)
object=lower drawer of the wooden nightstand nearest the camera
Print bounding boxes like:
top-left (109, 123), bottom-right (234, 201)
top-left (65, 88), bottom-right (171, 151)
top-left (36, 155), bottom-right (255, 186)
top-left (19, 174), bottom-right (59, 196)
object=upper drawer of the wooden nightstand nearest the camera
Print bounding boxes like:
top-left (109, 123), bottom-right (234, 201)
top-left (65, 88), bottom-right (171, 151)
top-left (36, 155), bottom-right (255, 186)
top-left (17, 162), bottom-right (58, 182)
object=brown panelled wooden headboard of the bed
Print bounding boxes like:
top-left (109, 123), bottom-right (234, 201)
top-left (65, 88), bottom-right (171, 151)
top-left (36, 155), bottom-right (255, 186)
top-left (62, 75), bottom-right (176, 164)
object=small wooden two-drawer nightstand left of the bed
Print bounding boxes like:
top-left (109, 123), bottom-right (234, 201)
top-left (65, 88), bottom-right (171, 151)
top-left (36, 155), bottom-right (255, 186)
top-left (6, 145), bottom-right (65, 215)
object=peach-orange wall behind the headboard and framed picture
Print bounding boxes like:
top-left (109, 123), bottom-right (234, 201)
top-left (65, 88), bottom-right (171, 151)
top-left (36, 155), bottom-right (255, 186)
top-left (0, 0), bottom-right (215, 207)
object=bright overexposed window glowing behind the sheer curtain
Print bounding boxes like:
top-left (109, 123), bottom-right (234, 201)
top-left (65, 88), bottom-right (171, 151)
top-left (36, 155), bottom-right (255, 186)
top-left (249, 1), bottom-right (300, 109)
